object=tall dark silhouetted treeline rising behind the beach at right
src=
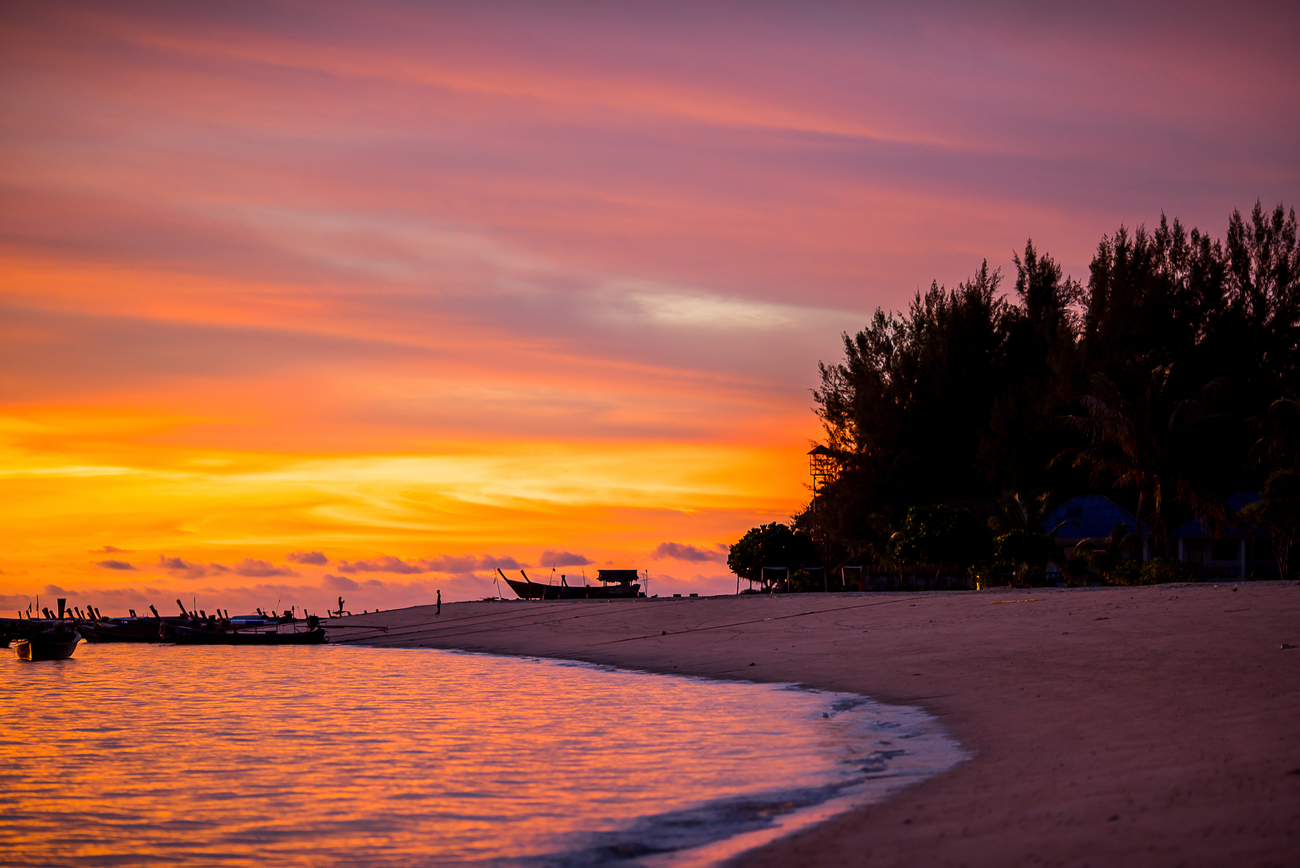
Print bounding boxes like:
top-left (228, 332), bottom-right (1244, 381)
top-left (774, 203), bottom-right (1300, 582)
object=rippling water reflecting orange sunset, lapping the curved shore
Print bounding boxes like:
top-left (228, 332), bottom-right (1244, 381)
top-left (0, 645), bottom-right (962, 865)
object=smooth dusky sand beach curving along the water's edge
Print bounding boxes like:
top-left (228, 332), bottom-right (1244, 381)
top-left (332, 582), bottom-right (1300, 867)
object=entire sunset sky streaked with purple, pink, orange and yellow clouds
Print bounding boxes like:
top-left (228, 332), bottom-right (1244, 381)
top-left (0, 0), bottom-right (1300, 615)
